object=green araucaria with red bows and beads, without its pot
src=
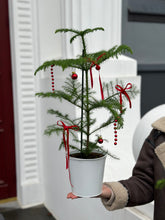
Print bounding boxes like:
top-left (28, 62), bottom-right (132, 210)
top-left (35, 27), bottom-right (138, 158)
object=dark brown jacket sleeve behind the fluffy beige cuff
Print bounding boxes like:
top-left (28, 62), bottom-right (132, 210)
top-left (120, 132), bottom-right (155, 207)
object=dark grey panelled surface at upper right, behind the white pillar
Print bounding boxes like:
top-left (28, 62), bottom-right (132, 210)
top-left (122, 0), bottom-right (165, 116)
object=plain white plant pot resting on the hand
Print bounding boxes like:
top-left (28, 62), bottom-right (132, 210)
top-left (69, 152), bottom-right (106, 197)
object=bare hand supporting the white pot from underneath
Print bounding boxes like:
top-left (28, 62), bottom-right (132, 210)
top-left (67, 184), bottom-right (112, 199)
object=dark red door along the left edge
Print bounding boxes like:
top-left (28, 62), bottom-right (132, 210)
top-left (0, 0), bottom-right (16, 199)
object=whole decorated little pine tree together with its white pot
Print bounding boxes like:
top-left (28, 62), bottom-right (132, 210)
top-left (35, 27), bottom-right (138, 197)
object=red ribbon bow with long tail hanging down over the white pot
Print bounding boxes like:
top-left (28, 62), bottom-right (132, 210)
top-left (57, 121), bottom-right (79, 187)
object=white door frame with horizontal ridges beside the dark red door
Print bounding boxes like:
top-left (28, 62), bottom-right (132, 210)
top-left (8, 0), bottom-right (44, 207)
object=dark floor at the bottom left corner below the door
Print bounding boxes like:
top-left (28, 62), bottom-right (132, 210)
top-left (0, 202), bottom-right (55, 220)
